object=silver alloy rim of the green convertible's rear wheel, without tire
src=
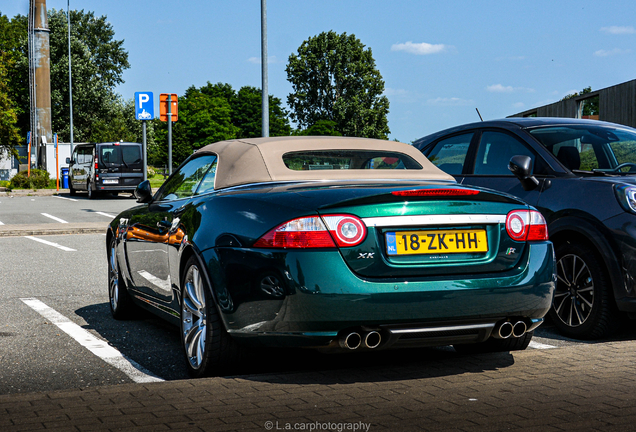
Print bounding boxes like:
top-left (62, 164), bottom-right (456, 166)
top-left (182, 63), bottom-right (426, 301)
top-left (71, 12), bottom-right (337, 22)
top-left (181, 265), bottom-right (208, 369)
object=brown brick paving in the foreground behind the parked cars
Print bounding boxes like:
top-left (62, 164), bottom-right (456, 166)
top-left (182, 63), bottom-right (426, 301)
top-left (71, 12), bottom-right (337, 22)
top-left (0, 341), bottom-right (636, 432)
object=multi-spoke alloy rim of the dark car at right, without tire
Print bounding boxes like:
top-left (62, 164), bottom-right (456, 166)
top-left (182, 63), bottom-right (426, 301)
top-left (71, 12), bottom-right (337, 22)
top-left (552, 254), bottom-right (594, 327)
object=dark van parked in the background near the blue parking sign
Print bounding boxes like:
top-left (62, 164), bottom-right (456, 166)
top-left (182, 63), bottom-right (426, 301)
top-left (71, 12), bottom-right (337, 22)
top-left (66, 142), bottom-right (144, 198)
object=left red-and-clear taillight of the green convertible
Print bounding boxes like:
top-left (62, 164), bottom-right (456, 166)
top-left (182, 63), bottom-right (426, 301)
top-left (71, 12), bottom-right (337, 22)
top-left (254, 215), bottom-right (367, 249)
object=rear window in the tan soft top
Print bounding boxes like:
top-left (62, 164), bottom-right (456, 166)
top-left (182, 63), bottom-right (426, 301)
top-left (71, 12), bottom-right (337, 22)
top-left (283, 150), bottom-right (422, 171)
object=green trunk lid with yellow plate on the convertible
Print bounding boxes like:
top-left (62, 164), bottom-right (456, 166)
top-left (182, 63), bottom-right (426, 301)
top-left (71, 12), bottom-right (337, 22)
top-left (319, 186), bottom-right (529, 278)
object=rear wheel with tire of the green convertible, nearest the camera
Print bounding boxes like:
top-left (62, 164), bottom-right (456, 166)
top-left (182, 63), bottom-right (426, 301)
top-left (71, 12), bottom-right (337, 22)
top-left (181, 256), bottom-right (241, 378)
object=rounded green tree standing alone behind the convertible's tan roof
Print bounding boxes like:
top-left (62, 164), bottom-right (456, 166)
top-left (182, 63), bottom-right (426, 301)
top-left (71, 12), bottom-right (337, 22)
top-left (286, 31), bottom-right (390, 139)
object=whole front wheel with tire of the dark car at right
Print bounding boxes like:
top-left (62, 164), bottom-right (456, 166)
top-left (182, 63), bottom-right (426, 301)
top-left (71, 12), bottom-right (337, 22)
top-left (549, 241), bottom-right (620, 339)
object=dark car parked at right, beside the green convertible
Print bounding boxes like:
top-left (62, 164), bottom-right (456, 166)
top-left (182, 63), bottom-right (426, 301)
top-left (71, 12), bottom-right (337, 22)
top-left (414, 118), bottom-right (636, 339)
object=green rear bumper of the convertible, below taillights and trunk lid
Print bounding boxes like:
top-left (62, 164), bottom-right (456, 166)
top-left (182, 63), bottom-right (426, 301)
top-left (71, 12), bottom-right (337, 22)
top-left (204, 242), bottom-right (555, 346)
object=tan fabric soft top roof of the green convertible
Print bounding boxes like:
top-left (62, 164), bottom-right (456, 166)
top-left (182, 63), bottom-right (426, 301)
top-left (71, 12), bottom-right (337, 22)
top-left (197, 136), bottom-right (455, 189)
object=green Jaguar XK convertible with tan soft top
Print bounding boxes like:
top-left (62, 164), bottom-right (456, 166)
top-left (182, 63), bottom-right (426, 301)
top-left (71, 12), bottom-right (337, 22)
top-left (106, 137), bottom-right (555, 376)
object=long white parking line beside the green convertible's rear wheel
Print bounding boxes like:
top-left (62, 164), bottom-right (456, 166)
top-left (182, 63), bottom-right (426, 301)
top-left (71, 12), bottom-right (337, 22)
top-left (20, 298), bottom-right (163, 383)
